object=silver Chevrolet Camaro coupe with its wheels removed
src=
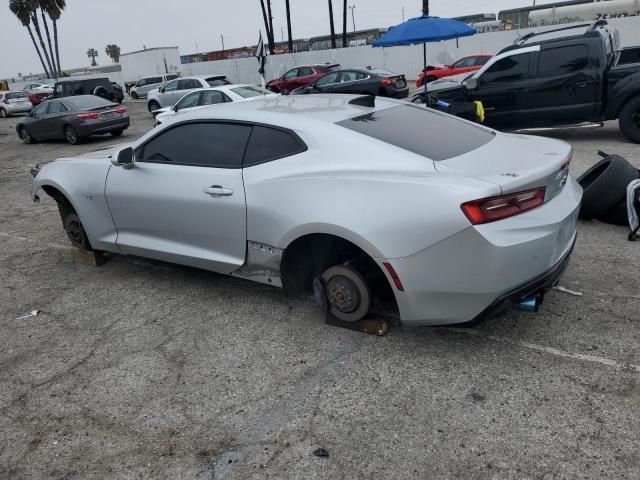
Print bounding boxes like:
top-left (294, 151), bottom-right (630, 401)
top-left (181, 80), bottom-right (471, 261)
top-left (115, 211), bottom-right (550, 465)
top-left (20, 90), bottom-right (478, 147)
top-left (32, 95), bottom-right (582, 325)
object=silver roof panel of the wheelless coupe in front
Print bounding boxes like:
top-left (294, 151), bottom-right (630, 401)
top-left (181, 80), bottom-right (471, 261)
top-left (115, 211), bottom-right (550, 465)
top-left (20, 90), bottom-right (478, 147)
top-left (168, 94), bottom-right (406, 130)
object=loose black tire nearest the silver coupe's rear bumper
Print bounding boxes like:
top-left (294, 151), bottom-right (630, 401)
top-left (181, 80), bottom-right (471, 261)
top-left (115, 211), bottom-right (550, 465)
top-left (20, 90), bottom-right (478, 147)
top-left (578, 155), bottom-right (638, 220)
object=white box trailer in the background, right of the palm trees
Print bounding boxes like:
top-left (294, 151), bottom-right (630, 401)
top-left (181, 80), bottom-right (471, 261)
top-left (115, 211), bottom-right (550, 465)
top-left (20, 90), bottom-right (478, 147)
top-left (120, 47), bottom-right (180, 83)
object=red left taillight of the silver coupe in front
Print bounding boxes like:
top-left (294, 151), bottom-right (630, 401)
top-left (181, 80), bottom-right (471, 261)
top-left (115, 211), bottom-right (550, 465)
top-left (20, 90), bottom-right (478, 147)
top-left (460, 188), bottom-right (547, 225)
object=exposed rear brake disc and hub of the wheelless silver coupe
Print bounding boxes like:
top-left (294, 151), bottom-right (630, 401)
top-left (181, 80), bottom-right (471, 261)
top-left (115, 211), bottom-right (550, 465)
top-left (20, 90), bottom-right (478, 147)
top-left (321, 265), bottom-right (372, 322)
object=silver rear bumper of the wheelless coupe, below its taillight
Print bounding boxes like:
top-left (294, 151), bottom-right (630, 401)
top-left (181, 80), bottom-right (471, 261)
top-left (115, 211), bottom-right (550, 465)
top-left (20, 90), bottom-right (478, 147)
top-left (379, 180), bottom-right (582, 326)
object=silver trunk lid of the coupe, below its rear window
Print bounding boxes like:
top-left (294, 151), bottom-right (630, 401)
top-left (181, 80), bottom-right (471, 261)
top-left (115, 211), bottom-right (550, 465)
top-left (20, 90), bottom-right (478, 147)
top-left (435, 133), bottom-right (572, 201)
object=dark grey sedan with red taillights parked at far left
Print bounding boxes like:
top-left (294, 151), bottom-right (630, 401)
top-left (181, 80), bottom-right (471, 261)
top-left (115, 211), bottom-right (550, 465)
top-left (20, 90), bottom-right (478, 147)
top-left (16, 95), bottom-right (130, 145)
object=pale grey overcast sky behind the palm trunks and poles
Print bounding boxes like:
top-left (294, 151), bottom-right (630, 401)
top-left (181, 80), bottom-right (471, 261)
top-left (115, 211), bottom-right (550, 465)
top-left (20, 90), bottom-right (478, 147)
top-left (0, 0), bottom-right (551, 79)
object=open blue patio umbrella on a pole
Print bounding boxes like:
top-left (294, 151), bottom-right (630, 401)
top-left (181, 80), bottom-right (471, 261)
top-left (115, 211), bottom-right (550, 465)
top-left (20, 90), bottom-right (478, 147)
top-left (373, 16), bottom-right (476, 101)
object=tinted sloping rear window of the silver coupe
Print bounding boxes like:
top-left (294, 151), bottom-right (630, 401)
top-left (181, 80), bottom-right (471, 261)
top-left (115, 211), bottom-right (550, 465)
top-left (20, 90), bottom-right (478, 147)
top-left (338, 105), bottom-right (494, 161)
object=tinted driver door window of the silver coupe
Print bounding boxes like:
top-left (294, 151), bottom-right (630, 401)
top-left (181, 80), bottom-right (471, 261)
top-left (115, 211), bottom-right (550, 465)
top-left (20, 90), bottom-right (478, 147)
top-left (135, 123), bottom-right (251, 168)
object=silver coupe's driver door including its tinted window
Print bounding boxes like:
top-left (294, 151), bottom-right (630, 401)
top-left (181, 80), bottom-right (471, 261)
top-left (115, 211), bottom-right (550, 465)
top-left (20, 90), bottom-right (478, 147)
top-left (105, 122), bottom-right (252, 274)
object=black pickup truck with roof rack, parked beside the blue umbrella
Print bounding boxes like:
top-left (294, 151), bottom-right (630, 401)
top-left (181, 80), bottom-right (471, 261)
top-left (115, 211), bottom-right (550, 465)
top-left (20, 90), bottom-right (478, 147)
top-left (414, 21), bottom-right (640, 143)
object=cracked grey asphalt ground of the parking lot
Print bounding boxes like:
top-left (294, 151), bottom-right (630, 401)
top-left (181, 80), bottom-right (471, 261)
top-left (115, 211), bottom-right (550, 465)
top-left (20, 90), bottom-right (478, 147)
top-left (0, 99), bottom-right (640, 480)
